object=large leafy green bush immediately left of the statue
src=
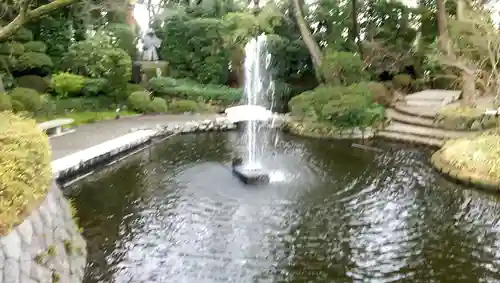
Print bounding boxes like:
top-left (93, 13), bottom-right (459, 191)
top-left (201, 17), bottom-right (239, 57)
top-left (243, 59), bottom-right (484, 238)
top-left (64, 36), bottom-right (132, 102)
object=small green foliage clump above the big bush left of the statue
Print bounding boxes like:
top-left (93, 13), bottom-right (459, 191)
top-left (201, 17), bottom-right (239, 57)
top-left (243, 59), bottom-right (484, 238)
top-left (100, 24), bottom-right (137, 58)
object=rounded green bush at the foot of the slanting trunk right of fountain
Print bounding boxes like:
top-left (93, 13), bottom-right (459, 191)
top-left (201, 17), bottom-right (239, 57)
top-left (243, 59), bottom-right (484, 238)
top-left (321, 49), bottom-right (369, 86)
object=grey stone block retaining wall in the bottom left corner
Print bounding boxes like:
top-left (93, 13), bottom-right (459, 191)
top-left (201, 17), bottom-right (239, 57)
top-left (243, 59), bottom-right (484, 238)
top-left (0, 184), bottom-right (87, 283)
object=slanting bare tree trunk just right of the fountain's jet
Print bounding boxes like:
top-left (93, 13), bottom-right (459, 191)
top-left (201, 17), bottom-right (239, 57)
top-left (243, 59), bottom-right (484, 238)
top-left (292, 0), bottom-right (323, 82)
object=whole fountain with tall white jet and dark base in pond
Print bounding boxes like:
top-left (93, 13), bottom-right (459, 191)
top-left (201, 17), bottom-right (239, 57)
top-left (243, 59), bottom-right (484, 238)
top-left (226, 34), bottom-right (274, 184)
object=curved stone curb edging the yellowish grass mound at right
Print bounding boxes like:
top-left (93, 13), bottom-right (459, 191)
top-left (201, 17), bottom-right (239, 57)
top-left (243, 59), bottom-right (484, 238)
top-left (430, 150), bottom-right (500, 192)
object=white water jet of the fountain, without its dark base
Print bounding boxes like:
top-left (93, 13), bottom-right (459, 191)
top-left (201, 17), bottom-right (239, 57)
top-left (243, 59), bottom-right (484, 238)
top-left (243, 34), bottom-right (274, 169)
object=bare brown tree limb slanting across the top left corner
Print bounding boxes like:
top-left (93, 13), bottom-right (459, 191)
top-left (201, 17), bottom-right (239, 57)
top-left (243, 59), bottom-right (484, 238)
top-left (0, 0), bottom-right (77, 41)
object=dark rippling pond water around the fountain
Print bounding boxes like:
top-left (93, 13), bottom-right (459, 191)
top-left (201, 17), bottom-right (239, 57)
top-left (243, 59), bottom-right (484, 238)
top-left (70, 133), bottom-right (500, 283)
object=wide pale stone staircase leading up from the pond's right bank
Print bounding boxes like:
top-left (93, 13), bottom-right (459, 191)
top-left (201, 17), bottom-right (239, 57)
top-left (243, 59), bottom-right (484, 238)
top-left (377, 90), bottom-right (477, 147)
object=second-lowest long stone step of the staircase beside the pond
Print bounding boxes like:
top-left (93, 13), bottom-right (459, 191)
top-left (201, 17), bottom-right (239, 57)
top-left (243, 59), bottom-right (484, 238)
top-left (384, 122), bottom-right (477, 139)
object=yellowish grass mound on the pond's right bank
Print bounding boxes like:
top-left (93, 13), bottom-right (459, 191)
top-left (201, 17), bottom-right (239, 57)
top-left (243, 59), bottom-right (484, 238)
top-left (441, 131), bottom-right (500, 180)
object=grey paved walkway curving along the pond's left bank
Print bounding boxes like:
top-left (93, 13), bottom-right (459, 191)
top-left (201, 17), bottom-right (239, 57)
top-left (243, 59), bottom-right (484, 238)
top-left (50, 114), bottom-right (218, 160)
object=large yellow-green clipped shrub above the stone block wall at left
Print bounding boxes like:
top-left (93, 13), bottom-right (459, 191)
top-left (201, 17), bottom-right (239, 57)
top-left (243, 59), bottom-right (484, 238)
top-left (0, 112), bottom-right (52, 235)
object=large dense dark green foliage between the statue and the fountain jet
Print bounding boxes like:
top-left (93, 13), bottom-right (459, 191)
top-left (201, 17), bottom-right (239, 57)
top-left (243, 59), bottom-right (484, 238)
top-left (159, 17), bottom-right (229, 84)
